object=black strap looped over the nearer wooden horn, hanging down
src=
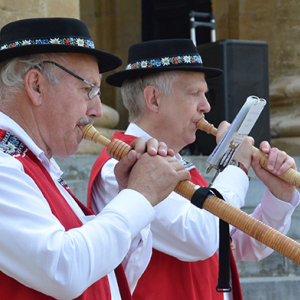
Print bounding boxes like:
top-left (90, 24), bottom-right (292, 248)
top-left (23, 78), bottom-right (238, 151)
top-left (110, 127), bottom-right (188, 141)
top-left (191, 187), bottom-right (231, 293)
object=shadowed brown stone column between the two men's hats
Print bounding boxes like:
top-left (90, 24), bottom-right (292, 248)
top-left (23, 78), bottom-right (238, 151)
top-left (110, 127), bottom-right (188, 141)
top-left (80, 0), bottom-right (142, 129)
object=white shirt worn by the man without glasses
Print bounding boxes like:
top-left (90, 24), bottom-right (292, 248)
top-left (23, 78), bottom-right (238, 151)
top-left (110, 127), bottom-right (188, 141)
top-left (93, 123), bottom-right (299, 299)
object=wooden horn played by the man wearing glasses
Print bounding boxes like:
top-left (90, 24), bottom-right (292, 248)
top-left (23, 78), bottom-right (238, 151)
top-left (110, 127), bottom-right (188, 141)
top-left (83, 124), bottom-right (300, 264)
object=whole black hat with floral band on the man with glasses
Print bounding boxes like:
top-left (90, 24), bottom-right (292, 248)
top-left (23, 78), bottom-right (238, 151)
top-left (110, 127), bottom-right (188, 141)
top-left (0, 18), bottom-right (122, 73)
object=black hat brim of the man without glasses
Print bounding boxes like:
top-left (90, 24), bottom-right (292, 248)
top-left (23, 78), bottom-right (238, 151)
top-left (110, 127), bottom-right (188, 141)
top-left (106, 65), bottom-right (223, 87)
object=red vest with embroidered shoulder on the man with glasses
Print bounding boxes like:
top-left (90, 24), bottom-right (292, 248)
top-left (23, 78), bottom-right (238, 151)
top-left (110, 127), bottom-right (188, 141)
top-left (0, 129), bottom-right (131, 300)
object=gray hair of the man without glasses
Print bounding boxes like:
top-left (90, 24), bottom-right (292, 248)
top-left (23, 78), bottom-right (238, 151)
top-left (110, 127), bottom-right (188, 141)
top-left (121, 71), bottom-right (179, 122)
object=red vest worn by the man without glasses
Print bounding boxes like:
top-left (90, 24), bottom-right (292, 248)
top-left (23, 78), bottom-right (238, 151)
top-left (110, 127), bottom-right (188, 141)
top-left (87, 132), bottom-right (242, 300)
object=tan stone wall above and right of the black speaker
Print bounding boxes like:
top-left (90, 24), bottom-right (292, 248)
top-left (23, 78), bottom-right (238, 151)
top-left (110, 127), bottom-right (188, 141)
top-left (212, 0), bottom-right (300, 82)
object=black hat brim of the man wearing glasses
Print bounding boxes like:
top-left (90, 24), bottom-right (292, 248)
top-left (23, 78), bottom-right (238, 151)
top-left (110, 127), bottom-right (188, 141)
top-left (0, 44), bottom-right (122, 73)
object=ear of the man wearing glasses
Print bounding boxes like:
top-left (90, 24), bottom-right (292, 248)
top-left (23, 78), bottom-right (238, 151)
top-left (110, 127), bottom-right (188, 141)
top-left (24, 69), bottom-right (44, 106)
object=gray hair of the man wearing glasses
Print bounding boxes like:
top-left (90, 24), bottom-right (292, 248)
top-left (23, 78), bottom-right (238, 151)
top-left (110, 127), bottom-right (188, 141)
top-left (0, 54), bottom-right (64, 101)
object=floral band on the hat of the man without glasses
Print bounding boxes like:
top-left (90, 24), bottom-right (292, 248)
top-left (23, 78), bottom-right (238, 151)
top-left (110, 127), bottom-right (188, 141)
top-left (126, 55), bottom-right (202, 70)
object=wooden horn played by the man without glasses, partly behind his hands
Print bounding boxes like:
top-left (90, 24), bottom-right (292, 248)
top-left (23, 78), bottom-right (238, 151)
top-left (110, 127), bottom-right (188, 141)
top-left (197, 118), bottom-right (300, 188)
